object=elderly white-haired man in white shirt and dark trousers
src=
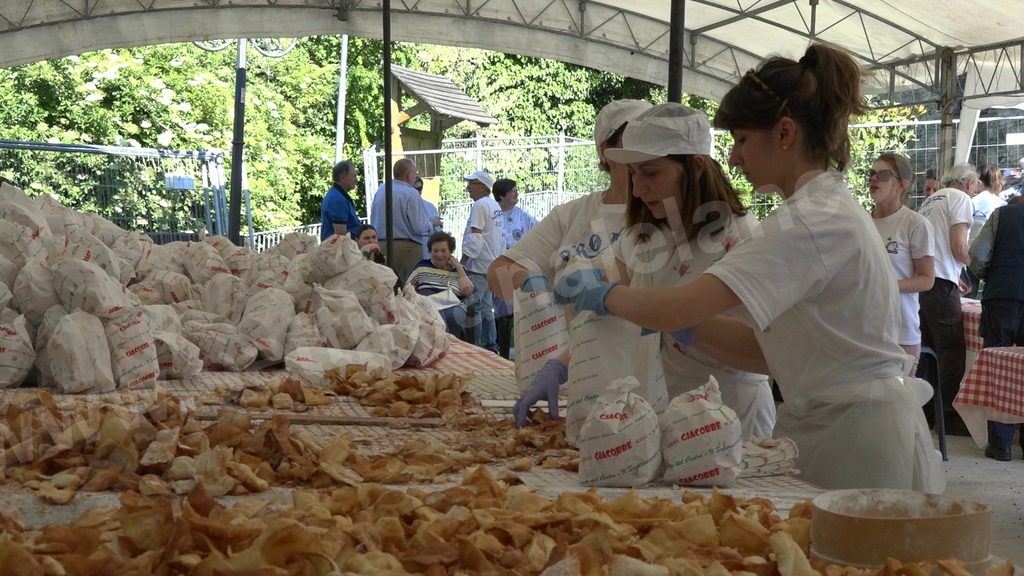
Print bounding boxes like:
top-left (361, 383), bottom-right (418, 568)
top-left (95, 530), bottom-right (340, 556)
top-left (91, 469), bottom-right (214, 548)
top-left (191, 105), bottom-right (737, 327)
top-left (918, 164), bottom-right (979, 436)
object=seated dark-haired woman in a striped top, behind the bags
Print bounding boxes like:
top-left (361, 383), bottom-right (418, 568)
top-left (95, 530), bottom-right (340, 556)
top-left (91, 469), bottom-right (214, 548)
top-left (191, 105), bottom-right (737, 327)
top-left (406, 232), bottom-right (473, 338)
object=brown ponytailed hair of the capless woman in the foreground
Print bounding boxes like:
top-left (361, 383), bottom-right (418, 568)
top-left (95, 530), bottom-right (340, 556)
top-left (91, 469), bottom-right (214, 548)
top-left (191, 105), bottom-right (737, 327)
top-left (714, 44), bottom-right (866, 172)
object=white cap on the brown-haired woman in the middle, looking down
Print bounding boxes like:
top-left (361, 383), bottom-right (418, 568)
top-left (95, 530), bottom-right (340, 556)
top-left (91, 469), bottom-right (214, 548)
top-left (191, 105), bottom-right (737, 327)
top-left (604, 102), bottom-right (712, 164)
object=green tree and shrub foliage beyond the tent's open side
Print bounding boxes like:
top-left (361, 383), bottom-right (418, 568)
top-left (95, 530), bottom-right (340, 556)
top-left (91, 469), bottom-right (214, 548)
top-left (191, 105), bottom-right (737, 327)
top-left (0, 37), bottom-right (912, 230)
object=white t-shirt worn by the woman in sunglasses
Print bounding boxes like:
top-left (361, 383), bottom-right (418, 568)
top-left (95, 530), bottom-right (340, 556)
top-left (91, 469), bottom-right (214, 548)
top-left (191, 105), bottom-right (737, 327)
top-left (871, 206), bottom-right (935, 345)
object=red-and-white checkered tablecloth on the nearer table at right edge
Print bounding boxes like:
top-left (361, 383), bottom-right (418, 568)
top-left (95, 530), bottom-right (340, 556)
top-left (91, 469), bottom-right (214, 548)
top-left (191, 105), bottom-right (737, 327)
top-left (953, 346), bottom-right (1024, 447)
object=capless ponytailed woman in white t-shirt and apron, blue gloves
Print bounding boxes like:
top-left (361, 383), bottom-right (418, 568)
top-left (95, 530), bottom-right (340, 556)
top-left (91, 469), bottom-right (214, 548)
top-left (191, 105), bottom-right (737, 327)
top-left (555, 44), bottom-right (943, 491)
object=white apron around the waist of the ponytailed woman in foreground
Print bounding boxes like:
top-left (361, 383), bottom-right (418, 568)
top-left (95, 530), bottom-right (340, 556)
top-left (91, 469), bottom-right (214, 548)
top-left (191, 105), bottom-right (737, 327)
top-left (775, 377), bottom-right (945, 494)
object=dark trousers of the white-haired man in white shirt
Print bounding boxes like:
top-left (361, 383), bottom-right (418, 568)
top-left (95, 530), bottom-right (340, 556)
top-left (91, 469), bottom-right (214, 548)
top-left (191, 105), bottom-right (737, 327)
top-left (921, 278), bottom-right (967, 415)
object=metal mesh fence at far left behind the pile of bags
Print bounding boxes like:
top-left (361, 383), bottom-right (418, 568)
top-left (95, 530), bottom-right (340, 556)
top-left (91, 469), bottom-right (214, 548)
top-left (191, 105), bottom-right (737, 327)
top-left (0, 139), bottom-right (235, 243)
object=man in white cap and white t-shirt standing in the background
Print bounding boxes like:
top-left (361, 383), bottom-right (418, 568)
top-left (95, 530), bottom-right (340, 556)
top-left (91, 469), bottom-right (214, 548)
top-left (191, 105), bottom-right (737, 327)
top-left (462, 170), bottom-right (505, 354)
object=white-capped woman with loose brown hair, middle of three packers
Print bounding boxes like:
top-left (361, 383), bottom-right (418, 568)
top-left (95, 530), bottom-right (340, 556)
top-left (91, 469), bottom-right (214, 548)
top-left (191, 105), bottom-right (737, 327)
top-left (605, 102), bottom-right (775, 438)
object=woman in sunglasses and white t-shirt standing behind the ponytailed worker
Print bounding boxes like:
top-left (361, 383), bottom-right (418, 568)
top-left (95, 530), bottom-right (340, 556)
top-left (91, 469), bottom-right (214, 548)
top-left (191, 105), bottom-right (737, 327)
top-left (868, 152), bottom-right (935, 374)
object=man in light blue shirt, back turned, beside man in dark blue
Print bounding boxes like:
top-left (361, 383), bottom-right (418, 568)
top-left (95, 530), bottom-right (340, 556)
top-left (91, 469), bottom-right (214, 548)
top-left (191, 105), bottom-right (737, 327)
top-left (370, 158), bottom-right (433, 286)
